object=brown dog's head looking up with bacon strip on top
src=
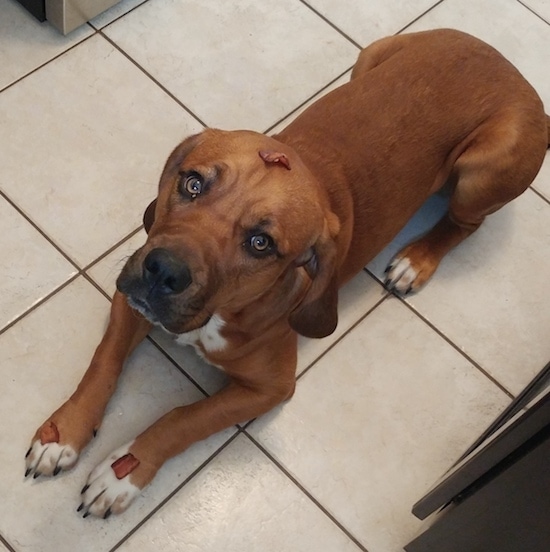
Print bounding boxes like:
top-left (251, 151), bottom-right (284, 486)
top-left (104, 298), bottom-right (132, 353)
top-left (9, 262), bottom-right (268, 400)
top-left (117, 130), bottom-right (339, 337)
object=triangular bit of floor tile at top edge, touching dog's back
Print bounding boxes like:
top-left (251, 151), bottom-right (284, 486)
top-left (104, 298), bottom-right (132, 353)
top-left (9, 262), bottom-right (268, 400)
top-left (306, 0), bottom-right (437, 47)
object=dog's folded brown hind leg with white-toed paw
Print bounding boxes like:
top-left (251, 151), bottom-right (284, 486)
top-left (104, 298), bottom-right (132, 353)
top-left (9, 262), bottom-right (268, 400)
top-left (386, 110), bottom-right (549, 295)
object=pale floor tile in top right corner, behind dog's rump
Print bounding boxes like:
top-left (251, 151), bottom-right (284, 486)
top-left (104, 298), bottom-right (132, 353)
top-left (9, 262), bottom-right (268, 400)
top-left (406, 0), bottom-right (550, 106)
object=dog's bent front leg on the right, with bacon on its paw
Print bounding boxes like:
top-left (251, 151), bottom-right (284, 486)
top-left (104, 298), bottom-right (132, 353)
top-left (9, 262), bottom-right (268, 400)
top-left (78, 337), bottom-right (296, 518)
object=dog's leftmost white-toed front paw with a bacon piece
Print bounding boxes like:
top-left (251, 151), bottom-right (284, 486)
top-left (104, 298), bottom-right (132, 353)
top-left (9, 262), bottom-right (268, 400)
top-left (25, 421), bottom-right (78, 479)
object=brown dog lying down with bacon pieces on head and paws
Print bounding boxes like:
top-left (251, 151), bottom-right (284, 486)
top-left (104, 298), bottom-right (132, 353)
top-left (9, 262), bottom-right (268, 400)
top-left (26, 30), bottom-right (550, 517)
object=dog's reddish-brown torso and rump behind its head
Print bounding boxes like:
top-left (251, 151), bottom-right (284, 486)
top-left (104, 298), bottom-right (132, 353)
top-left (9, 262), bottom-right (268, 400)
top-left (276, 29), bottom-right (548, 281)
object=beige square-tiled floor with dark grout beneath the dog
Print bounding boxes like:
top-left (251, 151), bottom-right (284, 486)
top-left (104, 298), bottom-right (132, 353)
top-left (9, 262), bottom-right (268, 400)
top-left (0, 0), bottom-right (550, 552)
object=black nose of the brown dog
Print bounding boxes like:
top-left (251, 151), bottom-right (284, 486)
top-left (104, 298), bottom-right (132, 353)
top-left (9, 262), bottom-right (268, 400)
top-left (143, 248), bottom-right (192, 295)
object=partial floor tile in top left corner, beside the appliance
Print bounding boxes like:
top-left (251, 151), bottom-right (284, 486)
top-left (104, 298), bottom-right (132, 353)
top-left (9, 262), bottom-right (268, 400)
top-left (0, 0), bottom-right (93, 90)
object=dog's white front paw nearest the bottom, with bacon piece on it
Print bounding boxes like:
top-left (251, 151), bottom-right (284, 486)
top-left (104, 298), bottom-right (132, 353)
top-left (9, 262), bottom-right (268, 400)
top-left (77, 443), bottom-right (152, 519)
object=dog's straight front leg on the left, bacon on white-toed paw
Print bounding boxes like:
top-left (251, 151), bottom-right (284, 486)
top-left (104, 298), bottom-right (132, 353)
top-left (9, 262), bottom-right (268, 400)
top-left (25, 292), bottom-right (151, 478)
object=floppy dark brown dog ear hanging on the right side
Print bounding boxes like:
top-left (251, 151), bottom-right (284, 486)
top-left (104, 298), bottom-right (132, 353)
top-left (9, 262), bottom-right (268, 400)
top-left (289, 213), bottom-right (340, 337)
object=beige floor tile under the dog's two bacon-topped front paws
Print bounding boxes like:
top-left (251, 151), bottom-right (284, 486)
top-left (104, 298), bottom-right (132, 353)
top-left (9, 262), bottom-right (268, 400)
top-left (0, 278), bottom-right (234, 552)
